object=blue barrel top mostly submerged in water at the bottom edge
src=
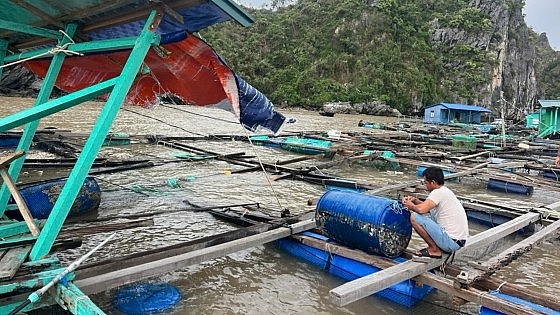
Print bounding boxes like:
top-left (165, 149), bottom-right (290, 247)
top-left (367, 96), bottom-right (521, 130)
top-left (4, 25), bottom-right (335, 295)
top-left (113, 282), bottom-right (181, 315)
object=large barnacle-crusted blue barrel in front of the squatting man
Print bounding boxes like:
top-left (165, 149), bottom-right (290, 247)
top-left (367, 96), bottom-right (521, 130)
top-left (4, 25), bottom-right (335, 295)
top-left (315, 190), bottom-right (412, 257)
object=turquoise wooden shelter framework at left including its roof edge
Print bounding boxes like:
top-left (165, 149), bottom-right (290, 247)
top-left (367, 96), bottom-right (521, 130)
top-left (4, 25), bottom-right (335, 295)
top-left (0, 0), bottom-right (253, 314)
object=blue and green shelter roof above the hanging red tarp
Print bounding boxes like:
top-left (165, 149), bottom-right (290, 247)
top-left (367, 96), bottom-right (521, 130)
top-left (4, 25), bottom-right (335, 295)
top-left (0, 0), bottom-right (254, 51)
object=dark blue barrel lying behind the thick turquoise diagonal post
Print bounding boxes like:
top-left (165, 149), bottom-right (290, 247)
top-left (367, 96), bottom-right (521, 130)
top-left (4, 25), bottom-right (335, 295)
top-left (6, 177), bottom-right (101, 219)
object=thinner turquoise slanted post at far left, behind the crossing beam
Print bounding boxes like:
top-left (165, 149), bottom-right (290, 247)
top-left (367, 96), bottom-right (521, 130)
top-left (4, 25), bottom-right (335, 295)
top-left (0, 23), bottom-right (78, 216)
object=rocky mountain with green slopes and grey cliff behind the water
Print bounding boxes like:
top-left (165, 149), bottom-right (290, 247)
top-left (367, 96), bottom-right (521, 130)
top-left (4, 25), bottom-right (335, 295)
top-left (0, 0), bottom-right (560, 119)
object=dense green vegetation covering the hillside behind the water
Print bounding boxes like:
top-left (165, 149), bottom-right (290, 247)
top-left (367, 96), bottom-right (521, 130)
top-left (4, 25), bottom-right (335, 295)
top-left (200, 0), bottom-right (556, 112)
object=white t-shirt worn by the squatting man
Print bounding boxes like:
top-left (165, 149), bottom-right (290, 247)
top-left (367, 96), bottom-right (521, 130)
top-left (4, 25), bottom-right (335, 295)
top-left (427, 186), bottom-right (469, 240)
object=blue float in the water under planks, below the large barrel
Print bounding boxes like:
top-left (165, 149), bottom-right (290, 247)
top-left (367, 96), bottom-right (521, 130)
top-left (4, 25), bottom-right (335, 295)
top-left (275, 232), bottom-right (433, 308)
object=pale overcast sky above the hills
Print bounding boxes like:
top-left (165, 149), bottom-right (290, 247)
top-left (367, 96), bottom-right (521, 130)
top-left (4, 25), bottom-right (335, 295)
top-left (237, 0), bottom-right (560, 50)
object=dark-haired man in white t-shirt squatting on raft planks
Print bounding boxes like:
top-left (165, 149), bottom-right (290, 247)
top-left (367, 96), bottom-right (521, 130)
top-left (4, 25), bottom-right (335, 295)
top-left (402, 167), bottom-right (469, 258)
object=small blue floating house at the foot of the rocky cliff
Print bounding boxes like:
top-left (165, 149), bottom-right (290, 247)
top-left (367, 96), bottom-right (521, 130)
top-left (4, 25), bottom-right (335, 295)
top-left (424, 103), bottom-right (491, 124)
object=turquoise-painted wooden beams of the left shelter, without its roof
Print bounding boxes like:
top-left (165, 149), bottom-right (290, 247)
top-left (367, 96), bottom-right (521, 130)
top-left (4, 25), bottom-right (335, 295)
top-left (0, 10), bottom-right (163, 314)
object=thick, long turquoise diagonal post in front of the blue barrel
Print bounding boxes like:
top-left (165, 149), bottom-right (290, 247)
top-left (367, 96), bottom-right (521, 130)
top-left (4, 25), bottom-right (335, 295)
top-left (29, 11), bottom-right (162, 260)
